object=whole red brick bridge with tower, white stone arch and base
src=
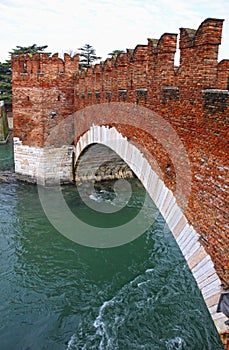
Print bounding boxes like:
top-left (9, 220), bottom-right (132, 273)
top-left (12, 19), bottom-right (229, 344)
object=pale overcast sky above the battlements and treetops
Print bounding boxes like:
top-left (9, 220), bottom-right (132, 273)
top-left (0, 0), bottom-right (229, 62)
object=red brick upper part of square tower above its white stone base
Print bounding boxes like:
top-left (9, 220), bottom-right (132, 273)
top-left (12, 54), bottom-right (78, 147)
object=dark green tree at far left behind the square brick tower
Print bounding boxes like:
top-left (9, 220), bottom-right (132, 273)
top-left (0, 44), bottom-right (50, 105)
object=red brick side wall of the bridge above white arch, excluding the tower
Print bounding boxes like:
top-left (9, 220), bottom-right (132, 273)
top-left (70, 19), bottom-right (229, 287)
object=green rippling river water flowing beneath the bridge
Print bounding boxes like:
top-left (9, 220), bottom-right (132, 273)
top-left (0, 144), bottom-right (223, 350)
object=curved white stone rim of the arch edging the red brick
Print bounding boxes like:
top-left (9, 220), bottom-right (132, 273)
top-left (75, 125), bottom-right (226, 332)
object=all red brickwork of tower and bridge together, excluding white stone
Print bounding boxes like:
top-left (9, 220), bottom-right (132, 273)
top-left (12, 19), bottom-right (229, 344)
